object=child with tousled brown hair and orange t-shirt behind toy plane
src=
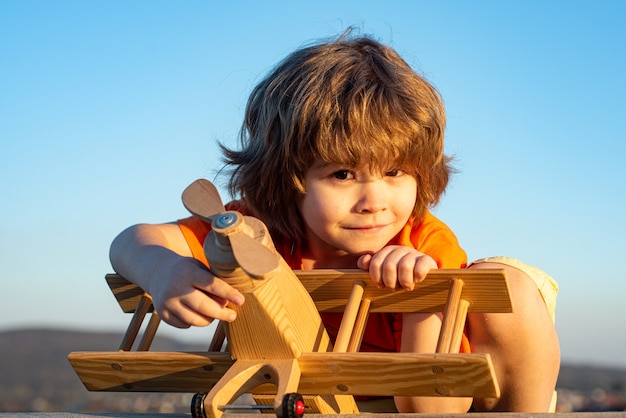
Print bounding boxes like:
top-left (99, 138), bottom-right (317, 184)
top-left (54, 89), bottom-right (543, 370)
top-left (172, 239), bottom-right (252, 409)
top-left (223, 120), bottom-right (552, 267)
top-left (110, 34), bottom-right (560, 413)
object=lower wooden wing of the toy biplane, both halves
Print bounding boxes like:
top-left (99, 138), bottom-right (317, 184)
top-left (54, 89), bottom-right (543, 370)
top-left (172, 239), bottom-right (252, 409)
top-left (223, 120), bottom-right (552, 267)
top-left (69, 352), bottom-right (499, 397)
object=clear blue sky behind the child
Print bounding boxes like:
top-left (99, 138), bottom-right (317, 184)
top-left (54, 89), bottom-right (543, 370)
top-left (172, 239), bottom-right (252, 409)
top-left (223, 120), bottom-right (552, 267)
top-left (0, 0), bottom-right (626, 367)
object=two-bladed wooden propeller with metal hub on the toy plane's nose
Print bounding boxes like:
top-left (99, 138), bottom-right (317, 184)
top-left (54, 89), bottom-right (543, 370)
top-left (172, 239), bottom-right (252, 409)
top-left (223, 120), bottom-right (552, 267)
top-left (182, 179), bottom-right (279, 279)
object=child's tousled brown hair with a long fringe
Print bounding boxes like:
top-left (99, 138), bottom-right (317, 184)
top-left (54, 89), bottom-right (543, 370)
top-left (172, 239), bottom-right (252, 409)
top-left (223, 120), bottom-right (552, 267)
top-left (221, 31), bottom-right (452, 240)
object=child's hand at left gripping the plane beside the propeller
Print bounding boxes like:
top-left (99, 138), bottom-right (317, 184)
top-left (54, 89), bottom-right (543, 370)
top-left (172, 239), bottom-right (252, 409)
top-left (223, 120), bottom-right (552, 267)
top-left (150, 257), bottom-right (244, 328)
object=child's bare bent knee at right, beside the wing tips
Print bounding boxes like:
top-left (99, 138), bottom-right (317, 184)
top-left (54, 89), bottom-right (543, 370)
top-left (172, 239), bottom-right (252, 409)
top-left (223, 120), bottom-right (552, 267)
top-left (468, 262), bottom-right (560, 411)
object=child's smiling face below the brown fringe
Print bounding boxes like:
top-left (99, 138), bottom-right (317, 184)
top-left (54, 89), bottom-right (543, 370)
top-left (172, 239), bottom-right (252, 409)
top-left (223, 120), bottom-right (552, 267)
top-left (300, 160), bottom-right (417, 258)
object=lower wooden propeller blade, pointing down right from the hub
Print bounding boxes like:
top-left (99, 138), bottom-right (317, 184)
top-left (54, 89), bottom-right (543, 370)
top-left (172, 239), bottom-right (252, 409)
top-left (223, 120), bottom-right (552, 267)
top-left (228, 232), bottom-right (279, 279)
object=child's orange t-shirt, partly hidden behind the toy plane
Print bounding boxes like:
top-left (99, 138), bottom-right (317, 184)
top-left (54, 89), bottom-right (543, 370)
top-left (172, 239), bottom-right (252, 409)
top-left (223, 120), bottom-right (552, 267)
top-left (178, 206), bottom-right (470, 352)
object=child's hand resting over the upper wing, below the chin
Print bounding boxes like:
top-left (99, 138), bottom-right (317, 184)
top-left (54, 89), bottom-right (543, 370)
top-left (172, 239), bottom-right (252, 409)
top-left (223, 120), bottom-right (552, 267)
top-left (357, 245), bottom-right (437, 290)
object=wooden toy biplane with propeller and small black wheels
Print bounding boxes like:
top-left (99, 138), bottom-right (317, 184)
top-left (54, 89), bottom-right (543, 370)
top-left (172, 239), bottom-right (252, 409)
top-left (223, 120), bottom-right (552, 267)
top-left (68, 180), bottom-right (512, 418)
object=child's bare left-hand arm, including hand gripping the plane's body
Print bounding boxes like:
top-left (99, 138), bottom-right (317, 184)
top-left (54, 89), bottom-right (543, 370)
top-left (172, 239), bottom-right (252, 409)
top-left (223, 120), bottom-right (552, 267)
top-left (109, 223), bottom-right (244, 328)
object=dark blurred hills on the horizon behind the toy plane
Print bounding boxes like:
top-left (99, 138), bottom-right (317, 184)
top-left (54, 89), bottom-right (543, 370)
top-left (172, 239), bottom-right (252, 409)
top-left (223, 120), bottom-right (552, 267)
top-left (0, 329), bottom-right (626, 413)
